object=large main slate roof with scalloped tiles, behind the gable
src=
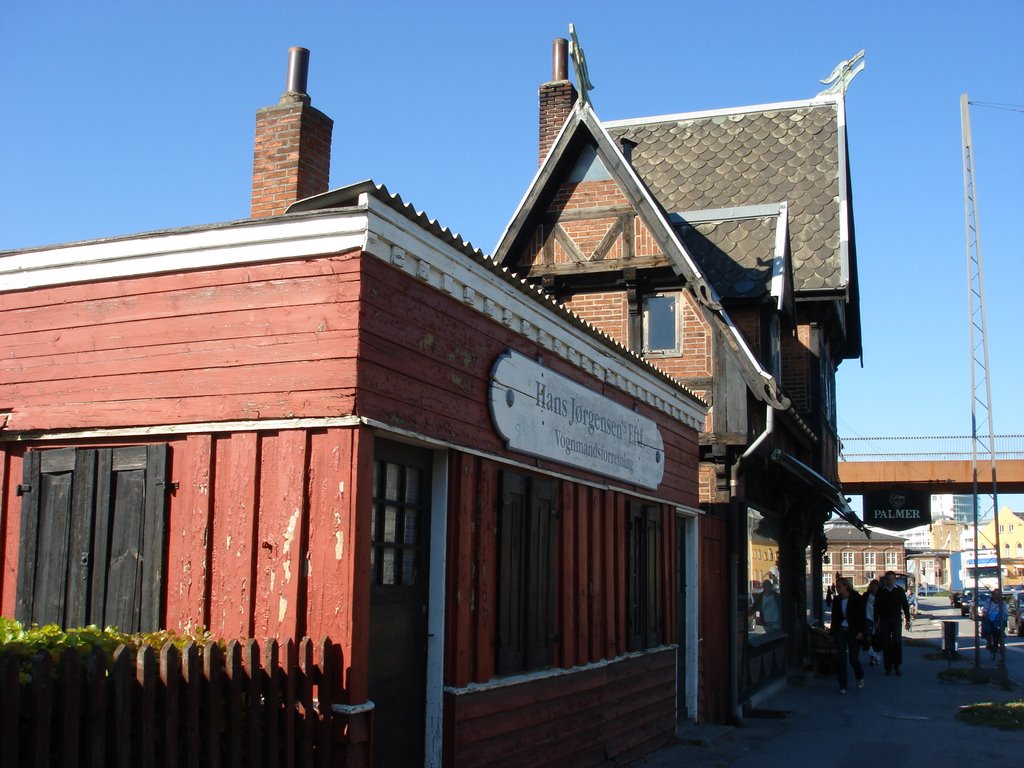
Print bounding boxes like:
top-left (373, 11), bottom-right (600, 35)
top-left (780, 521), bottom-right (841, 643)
top-left (606, 101), bottom-right (846, 293)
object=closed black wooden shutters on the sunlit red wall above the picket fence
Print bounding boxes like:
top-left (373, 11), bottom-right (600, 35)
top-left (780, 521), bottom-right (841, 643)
top-left (15, 443), bottom-right (168, 632)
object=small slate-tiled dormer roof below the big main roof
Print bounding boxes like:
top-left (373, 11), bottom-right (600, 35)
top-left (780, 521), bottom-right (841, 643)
top-left (676, 216), bottom-right (778, 299)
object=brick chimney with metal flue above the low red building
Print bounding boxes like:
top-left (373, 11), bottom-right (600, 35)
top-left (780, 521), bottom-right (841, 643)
top-left (250, 48), bottom-right (334, 218)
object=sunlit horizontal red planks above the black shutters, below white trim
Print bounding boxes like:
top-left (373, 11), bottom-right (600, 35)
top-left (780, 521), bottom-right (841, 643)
top-left (0, 252), bottom-right (359, 430)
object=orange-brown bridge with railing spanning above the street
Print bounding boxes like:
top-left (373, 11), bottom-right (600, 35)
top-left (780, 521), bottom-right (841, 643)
top-left (839, 434), bottom-right (1024, 495)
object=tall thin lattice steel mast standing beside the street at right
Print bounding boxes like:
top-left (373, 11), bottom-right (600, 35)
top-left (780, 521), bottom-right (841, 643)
top-left (961, 93), bottom-right (1007, 670)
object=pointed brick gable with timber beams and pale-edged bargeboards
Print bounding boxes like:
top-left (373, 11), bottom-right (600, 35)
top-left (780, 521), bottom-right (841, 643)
top-left (494, 102), bottom-right (790, 410)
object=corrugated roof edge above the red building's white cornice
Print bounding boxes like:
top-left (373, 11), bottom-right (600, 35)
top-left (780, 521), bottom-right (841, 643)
top-left (284, 179), bottom-right (709, 408)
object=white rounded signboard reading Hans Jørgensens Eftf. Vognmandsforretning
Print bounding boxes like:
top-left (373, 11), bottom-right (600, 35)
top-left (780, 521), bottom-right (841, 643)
top-left (488, 349), bottom-right (665, 488)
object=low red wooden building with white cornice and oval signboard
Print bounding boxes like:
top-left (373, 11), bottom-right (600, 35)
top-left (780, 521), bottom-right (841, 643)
top-left (0, 51), bottom-right (707, 766)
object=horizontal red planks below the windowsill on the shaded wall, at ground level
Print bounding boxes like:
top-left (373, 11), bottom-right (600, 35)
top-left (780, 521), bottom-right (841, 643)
top-left (445, 648), bottom-right (676, 768)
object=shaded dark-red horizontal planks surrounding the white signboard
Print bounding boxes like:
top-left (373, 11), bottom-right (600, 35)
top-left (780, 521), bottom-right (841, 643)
top-left (356, 258), bottom-right (698, 507)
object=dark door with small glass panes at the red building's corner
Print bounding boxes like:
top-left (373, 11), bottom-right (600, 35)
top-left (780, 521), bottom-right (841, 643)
top-left (370, 440), bottom-right (431, 767)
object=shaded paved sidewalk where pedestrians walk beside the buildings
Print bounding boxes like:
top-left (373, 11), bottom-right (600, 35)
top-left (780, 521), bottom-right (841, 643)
top-left (632, 621), bottom-right (1024, 768)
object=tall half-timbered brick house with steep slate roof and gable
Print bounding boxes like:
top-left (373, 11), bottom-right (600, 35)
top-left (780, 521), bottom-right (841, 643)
top-left (495, 41), bottom-right (861, 721)
